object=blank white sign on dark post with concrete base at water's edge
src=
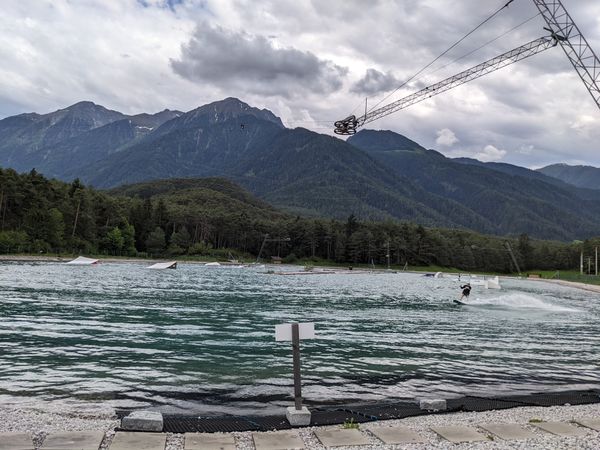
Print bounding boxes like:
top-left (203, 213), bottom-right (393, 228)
top-left (275, 323), bottom-right (315, 426)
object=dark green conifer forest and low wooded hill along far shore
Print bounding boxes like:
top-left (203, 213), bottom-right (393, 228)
top-left (0, 169), bottom-right (600, 273)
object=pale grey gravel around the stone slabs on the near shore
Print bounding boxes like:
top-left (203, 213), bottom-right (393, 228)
top-left (0, 404), bottom-right (600, 450)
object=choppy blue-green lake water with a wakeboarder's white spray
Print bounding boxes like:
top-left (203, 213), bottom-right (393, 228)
top-left (0, 262), bottom-right (600, 414)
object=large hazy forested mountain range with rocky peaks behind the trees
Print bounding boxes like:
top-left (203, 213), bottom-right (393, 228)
top-left (0, 98), bottom-right (600, 240)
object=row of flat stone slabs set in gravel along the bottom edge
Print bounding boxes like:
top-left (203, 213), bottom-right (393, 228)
top-left (0, 416), bottom-right (600, 450)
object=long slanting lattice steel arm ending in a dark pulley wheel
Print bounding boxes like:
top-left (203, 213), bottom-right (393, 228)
top-left (333, 37), bottom-right (557, 135)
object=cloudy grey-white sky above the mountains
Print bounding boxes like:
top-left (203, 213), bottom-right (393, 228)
top-left (0, 0), bottom-right (600, 168)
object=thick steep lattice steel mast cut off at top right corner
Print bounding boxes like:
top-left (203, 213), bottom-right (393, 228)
top-left (533, 0), bottom-right (600, 108)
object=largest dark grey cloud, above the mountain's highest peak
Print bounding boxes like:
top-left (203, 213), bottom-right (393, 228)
top-left (171, 24), bottom-right (348, 97)
